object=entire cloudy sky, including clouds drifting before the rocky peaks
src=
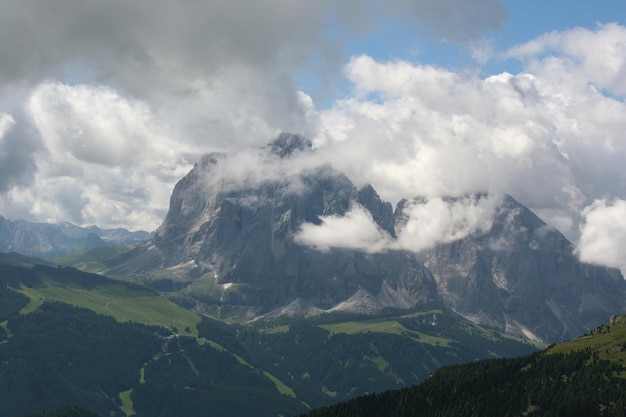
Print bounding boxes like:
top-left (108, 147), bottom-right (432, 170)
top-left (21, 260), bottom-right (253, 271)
top-left (0, 0), bottom-right (626, 271)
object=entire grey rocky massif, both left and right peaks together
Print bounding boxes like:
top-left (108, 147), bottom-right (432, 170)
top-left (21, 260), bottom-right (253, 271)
top-left (125, 134), bottom-right (626, 342)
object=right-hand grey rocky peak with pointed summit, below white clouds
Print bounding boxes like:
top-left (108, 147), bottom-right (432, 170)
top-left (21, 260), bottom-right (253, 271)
top-left (425, 197), bottom-right (626, 342)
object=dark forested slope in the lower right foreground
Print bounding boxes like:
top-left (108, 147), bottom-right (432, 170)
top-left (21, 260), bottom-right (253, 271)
top-left (296, 316), bottom-right (626, 417)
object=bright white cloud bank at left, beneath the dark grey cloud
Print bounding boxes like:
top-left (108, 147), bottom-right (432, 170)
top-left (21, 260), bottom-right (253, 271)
top-left (2, 83), bottom-right (198, 230)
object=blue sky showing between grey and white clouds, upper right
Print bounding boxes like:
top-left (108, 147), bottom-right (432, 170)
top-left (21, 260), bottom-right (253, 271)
top-left (296, 0), bottom-right (626, 103)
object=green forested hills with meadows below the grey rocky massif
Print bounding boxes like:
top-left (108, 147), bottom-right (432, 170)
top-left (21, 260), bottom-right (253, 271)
top-left (0, 254), bottom-right (537, 417)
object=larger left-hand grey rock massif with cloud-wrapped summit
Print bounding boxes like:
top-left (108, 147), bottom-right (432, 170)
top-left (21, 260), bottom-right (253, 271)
top-left (154, 134), bottom-right (441, 312)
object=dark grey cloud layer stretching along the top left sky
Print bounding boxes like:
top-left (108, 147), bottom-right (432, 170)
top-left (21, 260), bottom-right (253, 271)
top-left (0, 0), bottom-right (504, 110)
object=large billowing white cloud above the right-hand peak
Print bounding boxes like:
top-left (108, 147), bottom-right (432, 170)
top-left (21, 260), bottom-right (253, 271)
top-left (315, 24), bottom-right (626, 244)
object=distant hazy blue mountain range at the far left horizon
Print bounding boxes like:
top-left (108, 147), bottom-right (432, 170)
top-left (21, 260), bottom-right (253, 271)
top-left (0, 216), bottom-right (152, 260)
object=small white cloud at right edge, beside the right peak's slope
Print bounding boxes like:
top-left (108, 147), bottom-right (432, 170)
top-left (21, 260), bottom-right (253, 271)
top-left (577, 199), bottom-right (626, 275)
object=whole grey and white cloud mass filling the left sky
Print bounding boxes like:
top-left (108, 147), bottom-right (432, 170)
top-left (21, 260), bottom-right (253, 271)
top-left (0, 0), bottom-right (508, 230)
